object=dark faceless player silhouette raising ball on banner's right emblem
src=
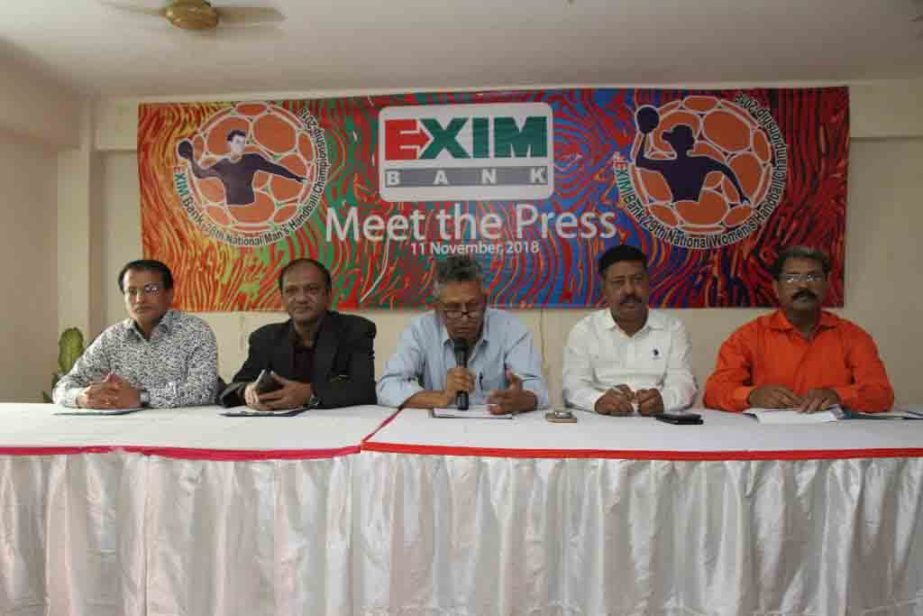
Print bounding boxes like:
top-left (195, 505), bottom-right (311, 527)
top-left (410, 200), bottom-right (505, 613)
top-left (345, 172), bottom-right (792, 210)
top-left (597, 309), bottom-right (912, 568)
top-left (635, 105), bottom-right (750, 203)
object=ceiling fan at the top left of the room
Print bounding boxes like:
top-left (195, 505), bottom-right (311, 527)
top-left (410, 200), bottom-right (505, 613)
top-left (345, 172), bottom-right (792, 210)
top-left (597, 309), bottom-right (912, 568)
top-left (101, 0), bottom-right (285, 30)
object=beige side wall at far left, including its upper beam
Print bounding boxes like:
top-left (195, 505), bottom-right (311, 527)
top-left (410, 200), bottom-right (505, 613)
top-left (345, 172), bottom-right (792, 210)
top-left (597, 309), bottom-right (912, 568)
top-left (0, 57), bottom-right (81, 402)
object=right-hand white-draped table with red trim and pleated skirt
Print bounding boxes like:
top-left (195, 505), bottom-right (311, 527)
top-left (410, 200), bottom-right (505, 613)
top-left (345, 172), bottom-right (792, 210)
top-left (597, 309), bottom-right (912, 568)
top-left (356, 411), bottom-right (923, 615)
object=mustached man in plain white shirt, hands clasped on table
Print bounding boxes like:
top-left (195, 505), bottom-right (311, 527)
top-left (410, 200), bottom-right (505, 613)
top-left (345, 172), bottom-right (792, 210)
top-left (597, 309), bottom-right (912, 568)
top-left (564, 245), bottom-right (696, 415)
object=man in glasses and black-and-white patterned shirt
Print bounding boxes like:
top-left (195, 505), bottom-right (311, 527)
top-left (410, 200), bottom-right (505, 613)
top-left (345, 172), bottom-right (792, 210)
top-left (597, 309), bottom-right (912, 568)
top-left (53, 259), bottom-right (218, 409)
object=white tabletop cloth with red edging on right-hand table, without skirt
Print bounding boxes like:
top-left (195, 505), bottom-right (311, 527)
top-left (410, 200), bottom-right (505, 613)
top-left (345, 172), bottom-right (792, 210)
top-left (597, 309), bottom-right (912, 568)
top-left (365, 409), bottom-right (923, 460)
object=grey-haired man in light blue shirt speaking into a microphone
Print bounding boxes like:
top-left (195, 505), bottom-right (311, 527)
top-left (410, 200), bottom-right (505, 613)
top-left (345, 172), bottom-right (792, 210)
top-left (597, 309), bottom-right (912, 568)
top-left (378, 256), bottom-right (548, 414)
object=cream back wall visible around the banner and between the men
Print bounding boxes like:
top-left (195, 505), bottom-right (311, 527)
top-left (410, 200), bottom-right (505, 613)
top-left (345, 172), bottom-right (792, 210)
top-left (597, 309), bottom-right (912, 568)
top-left (83, 82), bottom-right (923, 410)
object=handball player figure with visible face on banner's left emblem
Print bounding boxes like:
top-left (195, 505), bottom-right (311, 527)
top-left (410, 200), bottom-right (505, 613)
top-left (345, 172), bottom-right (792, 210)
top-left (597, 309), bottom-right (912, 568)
top-left (177, 130), bottom-right (305, 205)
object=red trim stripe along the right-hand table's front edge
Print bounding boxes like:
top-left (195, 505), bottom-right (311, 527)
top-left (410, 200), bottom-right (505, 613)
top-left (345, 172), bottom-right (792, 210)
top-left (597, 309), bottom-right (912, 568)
top-left (362, 442), bottom-right (923, 462)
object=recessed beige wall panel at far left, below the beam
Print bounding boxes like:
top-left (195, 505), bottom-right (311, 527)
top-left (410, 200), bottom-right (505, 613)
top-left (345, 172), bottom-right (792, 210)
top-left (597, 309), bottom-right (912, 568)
top-left (0, 136), bottom-right (58, 402)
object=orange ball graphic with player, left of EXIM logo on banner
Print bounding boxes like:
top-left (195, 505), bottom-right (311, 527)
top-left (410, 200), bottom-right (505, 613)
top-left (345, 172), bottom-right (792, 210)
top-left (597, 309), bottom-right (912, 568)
top-left (177, 103), bottom-right (318, 237)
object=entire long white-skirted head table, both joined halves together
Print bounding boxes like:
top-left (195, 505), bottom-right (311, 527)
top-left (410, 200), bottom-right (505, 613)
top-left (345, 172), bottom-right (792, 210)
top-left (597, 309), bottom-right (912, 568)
top-left (0, 404), bottom-right (923, 616)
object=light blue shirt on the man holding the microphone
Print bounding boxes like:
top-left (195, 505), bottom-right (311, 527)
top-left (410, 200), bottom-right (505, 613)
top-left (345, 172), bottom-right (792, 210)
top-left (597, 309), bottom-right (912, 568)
top-left (376, 308), bottom-right (548, 408)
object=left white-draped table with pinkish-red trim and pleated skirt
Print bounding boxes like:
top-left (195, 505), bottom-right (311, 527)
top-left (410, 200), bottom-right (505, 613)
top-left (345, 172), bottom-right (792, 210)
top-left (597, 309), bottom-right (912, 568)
top-left (0, 404), bottom-right (394, 616)
